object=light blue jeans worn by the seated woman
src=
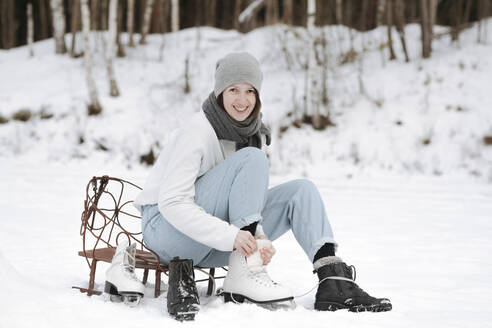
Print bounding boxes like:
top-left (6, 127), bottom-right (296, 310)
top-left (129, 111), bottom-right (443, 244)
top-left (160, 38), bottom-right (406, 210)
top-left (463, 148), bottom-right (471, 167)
top-left (142, 147), bottom-right (336, 267)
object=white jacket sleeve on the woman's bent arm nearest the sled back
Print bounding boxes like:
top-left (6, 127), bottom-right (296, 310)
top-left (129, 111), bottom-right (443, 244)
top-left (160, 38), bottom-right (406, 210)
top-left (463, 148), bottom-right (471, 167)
top-left (158, 131), bottom-right (239, 251)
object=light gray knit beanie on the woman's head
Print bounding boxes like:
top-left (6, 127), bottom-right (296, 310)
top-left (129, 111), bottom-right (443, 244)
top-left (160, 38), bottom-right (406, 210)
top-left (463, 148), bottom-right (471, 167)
top-left (214, 52), bottom-right (263, 97)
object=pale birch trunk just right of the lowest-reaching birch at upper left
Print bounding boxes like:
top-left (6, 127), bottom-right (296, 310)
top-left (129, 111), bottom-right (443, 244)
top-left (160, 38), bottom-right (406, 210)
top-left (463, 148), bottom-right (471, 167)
top-left (106, 0), bottom-right (120, 97)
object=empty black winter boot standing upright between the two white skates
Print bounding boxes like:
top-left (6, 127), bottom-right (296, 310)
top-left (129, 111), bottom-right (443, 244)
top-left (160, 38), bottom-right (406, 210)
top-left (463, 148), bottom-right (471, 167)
top-left (167, 257), bottom-right (200, 321)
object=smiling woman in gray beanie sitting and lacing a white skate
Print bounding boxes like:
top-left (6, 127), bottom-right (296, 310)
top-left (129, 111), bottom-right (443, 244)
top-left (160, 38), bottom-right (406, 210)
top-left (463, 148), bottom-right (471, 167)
top-left (135, 52), bottom-right (391, 311)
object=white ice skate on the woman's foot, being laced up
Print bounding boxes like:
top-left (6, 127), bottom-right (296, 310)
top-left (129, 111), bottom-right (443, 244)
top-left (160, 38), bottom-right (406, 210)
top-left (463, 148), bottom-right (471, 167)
top-left (223, 239), bottom-right (294, 307)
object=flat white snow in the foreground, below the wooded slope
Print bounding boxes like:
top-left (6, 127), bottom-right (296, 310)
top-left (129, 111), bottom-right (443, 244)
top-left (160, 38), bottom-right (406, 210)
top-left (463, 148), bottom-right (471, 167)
top-left (0, 160), bottom-right (492, 328)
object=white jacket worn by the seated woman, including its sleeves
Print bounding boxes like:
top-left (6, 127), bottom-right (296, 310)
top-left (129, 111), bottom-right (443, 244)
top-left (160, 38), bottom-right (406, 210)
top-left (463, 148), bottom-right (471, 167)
top-left (134, 111), bottom-right (263, 251)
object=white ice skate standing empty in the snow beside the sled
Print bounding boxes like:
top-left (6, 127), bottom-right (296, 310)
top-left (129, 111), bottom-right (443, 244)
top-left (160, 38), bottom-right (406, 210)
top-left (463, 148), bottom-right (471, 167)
top-left (104, 241), bottom-right (145, 307)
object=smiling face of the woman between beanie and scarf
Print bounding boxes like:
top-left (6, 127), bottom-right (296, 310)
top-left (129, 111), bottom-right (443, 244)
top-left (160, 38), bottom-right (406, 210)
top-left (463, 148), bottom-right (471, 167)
top-left (222, 83), bottom-right (256, 122)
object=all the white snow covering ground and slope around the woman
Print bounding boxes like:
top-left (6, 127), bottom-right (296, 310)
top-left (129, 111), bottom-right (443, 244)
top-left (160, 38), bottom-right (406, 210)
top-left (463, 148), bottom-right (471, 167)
top-left (0, 20), bottom-right (492, 328)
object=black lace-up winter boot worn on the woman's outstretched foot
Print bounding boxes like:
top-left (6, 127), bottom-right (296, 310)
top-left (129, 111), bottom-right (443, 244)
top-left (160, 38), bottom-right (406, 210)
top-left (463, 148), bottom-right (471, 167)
top-left (314, 256), bottom-right (392, 312)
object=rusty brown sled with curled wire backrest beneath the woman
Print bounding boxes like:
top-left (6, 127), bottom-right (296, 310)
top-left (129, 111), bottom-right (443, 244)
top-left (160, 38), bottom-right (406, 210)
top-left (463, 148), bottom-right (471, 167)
top-left (72, 175), bottom-right (227, 297)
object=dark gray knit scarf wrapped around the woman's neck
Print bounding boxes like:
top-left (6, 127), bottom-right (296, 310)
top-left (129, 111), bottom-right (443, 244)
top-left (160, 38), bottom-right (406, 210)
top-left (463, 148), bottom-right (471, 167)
top-left (202, 92), bottom-right (271, 150)
